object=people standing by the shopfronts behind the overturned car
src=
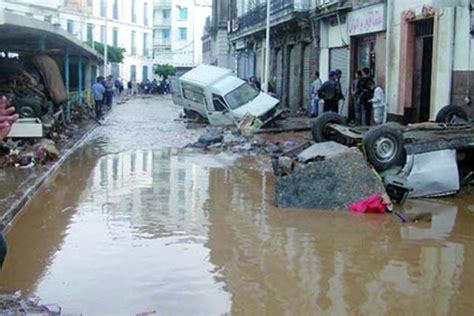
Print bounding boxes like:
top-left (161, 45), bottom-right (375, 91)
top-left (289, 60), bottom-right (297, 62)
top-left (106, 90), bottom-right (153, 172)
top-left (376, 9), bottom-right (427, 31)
top-left (308, 68), bottom-right (385, 125)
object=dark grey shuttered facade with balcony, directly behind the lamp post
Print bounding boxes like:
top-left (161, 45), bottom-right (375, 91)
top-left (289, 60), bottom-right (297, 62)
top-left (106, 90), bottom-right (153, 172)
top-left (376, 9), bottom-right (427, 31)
top-left (228, 0), bottom-right (317, 113)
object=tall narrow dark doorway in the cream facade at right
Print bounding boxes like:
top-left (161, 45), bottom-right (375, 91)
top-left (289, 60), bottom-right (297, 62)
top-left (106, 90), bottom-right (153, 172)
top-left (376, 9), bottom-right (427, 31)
top-left (410, 19), bottom-right (434, 123)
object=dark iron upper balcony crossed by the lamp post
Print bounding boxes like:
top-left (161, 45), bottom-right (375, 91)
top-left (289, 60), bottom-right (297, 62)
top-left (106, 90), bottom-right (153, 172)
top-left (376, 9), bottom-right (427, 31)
top-left (230, 0), bottom-right (311, 38)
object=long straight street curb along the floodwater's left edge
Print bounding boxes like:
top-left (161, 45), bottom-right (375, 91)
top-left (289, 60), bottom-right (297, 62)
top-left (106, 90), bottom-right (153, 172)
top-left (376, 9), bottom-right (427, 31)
top-left (0, 118), bottom-right (99, 233)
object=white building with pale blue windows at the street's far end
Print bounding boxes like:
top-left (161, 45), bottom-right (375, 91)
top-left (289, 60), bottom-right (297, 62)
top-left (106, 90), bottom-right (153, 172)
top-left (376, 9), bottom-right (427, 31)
top-left (153, 0), bottom-right (212, 70)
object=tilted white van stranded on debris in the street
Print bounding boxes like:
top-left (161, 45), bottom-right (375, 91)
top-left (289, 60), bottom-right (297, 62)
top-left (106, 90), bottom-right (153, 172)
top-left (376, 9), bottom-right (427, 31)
top-left (171, 65), bottom-right (282, 125)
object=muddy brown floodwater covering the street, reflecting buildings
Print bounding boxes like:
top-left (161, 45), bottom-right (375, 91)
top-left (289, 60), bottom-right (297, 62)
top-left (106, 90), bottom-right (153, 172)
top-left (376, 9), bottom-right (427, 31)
top-left (0, 98), bottom-right (474, 315)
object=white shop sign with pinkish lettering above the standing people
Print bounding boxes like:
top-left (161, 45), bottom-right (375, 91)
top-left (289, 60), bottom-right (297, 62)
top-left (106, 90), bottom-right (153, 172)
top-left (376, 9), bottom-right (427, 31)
top-left (347, 3), bottom-right (385, 36)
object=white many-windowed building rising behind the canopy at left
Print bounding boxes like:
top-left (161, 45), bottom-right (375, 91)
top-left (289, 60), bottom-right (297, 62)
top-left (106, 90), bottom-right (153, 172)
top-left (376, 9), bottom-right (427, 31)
top-left (0, 0), bottom-right (154, 81)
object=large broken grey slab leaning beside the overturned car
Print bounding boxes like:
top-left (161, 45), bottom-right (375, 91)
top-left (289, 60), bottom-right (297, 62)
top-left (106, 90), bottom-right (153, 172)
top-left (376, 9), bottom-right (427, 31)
top-left (276, 148), bottom-right (385, 210)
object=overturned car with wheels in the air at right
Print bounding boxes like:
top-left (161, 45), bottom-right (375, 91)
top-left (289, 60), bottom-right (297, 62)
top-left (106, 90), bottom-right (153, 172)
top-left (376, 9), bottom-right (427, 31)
top-left (312, 106), bottom-right (474, 201)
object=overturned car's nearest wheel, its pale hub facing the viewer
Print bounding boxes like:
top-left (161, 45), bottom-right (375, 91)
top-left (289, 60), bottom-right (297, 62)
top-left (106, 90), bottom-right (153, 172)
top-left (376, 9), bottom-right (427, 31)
top-left (363, 123), bottom-right (406, 172)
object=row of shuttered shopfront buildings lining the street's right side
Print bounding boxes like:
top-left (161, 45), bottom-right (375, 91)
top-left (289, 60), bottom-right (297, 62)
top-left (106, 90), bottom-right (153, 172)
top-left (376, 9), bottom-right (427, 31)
top-left (205, 0), bottom-right (474, 123)
